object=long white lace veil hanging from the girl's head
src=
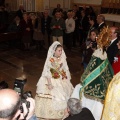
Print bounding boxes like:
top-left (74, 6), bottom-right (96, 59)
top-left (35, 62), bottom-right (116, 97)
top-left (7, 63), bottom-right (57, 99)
top-left (36, 41), bottom-right (71, 93)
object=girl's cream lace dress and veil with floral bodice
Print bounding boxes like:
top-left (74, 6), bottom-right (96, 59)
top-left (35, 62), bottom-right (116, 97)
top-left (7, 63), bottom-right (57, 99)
top-left (35, 41), bottom-right (73, 119)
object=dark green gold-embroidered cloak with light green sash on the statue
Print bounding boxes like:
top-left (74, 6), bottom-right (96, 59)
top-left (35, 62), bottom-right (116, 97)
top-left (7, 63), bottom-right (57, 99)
top-left (80, 56), bottom-right (113, 101)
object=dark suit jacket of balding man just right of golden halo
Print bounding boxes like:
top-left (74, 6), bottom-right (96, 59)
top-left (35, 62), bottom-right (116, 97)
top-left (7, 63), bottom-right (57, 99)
top-left (107, 39), bottom-right (118, 64)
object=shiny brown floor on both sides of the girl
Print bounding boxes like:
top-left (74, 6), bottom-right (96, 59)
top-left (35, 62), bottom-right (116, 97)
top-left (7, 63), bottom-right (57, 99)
top-left (0, 44), bottom-right (83, 97)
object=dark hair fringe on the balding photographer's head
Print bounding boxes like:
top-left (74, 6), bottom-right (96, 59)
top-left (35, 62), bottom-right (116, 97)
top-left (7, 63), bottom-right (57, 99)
top-left (0, 98), bottom-right (21, 120)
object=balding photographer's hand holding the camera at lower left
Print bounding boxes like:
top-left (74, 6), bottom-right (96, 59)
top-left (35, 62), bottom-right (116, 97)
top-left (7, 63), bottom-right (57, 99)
top-left (19, 98), bottom-right (35, 120)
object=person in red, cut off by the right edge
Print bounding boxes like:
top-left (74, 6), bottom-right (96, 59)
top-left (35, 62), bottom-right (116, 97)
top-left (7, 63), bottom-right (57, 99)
top-left (112, 39), bottom-right (120, 74)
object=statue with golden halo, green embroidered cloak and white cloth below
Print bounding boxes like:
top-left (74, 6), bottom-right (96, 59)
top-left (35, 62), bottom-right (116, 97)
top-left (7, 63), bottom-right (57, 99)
top-left (72, 28), bottom-right (113, 120)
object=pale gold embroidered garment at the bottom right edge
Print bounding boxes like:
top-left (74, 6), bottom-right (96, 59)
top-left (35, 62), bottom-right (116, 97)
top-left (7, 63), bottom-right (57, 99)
top-left (101, 72), bottom-right (120, 120)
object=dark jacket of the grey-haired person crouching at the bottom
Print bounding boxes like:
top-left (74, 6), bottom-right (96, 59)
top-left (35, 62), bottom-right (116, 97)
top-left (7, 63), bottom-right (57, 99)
top-left (64, 108), bottom-right (95, 120)
